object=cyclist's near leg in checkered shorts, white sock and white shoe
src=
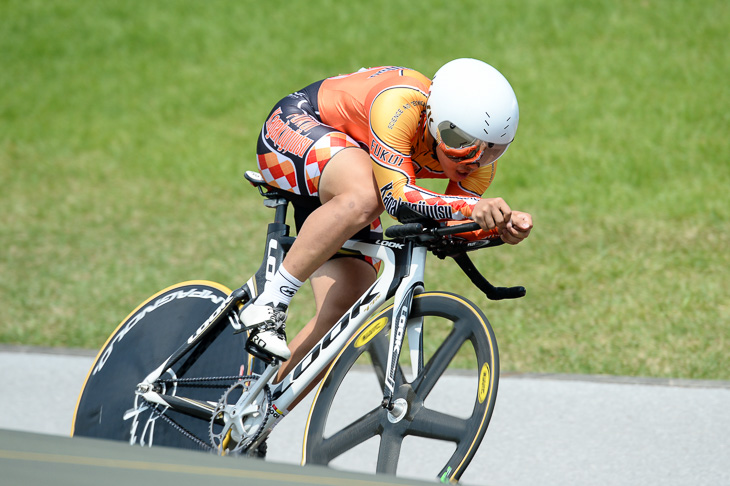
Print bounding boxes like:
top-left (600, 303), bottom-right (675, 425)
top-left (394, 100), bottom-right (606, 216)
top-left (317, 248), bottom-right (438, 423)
top-left (249, 90), bottom-right (384, 361)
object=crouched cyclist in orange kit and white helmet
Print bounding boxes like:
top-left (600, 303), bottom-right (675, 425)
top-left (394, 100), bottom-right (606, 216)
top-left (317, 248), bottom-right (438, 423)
top-left (241, 59), bottom-right (532, 377)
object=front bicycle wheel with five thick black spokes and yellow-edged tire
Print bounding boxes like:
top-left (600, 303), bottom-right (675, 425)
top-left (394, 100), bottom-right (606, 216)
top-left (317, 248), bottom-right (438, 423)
top-left (302, 292), bottom-right (499, 482)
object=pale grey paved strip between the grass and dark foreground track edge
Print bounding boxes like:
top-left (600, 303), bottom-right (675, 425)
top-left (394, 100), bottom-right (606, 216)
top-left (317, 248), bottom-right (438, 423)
top-left (0, 348), bottom-right (730, 486)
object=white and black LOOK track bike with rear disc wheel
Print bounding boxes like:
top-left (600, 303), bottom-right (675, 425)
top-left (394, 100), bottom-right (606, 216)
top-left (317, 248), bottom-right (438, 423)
top-left (72, 171), bottom-right (525, 482)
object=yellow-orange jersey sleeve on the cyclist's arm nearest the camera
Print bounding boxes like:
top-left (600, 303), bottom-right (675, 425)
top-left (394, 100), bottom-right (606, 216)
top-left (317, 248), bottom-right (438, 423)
top-left (369, 85), bottom-right (486, 221)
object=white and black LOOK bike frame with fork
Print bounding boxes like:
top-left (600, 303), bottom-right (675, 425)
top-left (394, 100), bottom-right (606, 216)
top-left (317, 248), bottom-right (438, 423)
top-left (137, 198), bottom-right (428, 436)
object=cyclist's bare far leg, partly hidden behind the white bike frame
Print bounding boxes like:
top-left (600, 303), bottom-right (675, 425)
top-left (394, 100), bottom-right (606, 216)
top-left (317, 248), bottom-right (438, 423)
top-left (277, 257), bottom-right (376, 410)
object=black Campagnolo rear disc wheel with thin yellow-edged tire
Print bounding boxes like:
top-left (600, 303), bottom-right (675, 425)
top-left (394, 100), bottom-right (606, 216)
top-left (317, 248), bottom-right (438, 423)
top-left (71, 280), bottom-right (263, 449)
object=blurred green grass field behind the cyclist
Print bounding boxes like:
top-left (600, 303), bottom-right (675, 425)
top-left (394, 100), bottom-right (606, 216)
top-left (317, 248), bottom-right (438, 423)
top-left (0, 0), bottom-right (730, 380)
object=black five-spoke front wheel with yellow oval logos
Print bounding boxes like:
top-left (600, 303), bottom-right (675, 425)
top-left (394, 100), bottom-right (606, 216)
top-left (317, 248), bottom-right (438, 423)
top-left (303, 292), bottom-right (499, 480)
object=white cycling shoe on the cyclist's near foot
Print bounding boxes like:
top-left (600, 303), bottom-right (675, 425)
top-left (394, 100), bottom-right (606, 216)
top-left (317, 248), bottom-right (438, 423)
top-left (240, 303), bottom-right (291, 361)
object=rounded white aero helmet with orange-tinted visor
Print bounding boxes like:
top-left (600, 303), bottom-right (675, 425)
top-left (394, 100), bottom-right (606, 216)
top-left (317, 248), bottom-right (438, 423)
top-left (427, 59), bottom-right (520, 167)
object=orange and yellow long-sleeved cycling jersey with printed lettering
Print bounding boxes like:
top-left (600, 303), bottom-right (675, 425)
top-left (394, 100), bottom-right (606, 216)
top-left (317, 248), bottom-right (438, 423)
top-left (317, 66), bottom-right (496, 221)
